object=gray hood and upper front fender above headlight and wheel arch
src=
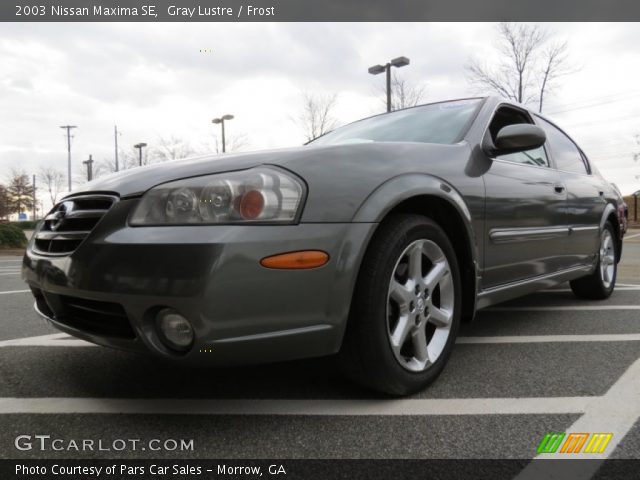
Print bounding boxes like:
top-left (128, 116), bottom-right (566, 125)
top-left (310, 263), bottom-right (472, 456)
top-left (66, 142), bottom-right (473, 222)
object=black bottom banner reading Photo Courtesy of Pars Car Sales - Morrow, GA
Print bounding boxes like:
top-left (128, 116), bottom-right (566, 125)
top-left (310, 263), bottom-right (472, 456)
top-left (0, 459), bottom-right (640, 480)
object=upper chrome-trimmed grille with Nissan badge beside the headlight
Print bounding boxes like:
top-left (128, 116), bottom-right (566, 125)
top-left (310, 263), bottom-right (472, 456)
top-left (33, 194), bottom-right (118, 255)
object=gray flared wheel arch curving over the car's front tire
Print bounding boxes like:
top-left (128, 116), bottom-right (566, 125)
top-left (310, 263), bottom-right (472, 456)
top-left (353, 174), bottom-right (479, 322)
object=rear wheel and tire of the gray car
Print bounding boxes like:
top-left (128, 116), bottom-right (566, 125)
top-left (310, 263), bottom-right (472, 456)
top-left (569, 222), bottom-right (618, 300)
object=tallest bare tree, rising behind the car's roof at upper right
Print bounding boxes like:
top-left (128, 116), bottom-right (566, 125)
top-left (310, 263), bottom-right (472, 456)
top-left (465, 22), bottom-right (572, 112)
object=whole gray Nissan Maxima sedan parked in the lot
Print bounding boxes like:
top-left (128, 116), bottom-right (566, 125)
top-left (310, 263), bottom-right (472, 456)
top-left (23, 98), bottom-right (624, 394)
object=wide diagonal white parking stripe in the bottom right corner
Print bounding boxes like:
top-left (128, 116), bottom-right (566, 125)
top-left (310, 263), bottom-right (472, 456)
top-left (515, 359), bottom-right (640, 480)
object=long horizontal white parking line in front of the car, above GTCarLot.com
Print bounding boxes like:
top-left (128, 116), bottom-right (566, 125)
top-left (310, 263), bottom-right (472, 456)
top-left (0, 397), bottom-right (593, 416)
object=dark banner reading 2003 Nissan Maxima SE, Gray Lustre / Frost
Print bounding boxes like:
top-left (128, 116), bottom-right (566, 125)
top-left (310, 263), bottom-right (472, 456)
top-left (0, 0), bottom-right (640, 22)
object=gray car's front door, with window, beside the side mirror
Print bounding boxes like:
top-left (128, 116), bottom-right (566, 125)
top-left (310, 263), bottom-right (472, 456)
top-left (483, 106), bottom-right (569, 288)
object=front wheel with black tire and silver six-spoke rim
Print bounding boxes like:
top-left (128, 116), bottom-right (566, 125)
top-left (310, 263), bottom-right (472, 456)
top-left (341, 215), bottom-right (462, 395)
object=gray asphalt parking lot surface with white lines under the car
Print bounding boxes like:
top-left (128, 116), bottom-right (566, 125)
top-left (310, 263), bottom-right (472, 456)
top-left (0, 231), bottom-right (640, 472)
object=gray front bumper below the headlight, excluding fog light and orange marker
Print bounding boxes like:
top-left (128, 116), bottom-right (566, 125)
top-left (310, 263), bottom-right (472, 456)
top-left (22, 199), bottom-right (375, 364)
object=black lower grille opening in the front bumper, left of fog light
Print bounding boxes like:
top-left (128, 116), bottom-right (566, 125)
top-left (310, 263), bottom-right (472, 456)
top-left (32, 288), bottom-right (136, 339)
